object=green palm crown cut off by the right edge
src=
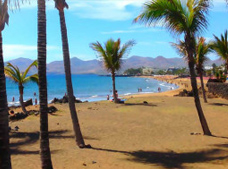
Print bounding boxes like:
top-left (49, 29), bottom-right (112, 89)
top-left (211, 30), bottom-right (228, 74)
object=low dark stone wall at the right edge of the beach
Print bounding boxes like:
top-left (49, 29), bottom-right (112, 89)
top-left (207, 82), bottom-right (228, 99)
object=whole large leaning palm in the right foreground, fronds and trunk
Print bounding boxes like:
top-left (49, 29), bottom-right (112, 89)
top-left (134, 0), bottom-right (211, 135)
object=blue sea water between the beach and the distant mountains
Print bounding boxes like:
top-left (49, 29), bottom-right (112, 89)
top-left (6, 74), bottom-right (178, 106)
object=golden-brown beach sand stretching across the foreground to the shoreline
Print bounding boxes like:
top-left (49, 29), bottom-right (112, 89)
top-left (10, 77), bottom-right (228, 169)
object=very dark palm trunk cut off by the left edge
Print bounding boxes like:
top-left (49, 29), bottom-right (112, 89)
top-left (0, 32), bottom-right (11, 169)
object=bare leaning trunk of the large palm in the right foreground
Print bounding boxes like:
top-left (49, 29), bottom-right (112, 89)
top-left (188, 60), bottom-right (211, 136)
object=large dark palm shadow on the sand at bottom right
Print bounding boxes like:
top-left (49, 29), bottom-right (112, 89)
top-left (92, 148), bottom-right (228, 169)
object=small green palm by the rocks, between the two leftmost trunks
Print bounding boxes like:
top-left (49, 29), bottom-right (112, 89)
top-left (5, 60), bottom-right (38, 114)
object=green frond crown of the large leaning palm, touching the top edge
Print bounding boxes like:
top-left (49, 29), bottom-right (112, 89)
top-left (134, 0), bottom-right (209, 34)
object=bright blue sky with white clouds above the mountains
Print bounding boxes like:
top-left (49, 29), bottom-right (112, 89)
top-left (3, 0), bottom-right (228, 63)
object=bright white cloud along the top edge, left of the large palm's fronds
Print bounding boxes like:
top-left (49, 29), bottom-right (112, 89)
top-left (15, 0), bottom-right (146, 21)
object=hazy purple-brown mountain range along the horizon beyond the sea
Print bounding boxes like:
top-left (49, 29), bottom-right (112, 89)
top-left (4, 56), bottom-right (223, 74)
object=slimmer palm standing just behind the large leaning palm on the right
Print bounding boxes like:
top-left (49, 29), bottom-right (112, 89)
top-left (195, 37), bottom-right (211, 103)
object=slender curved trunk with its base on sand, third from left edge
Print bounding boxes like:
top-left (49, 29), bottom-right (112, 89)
top-left (59, 10), bottom-right (85, 148)
